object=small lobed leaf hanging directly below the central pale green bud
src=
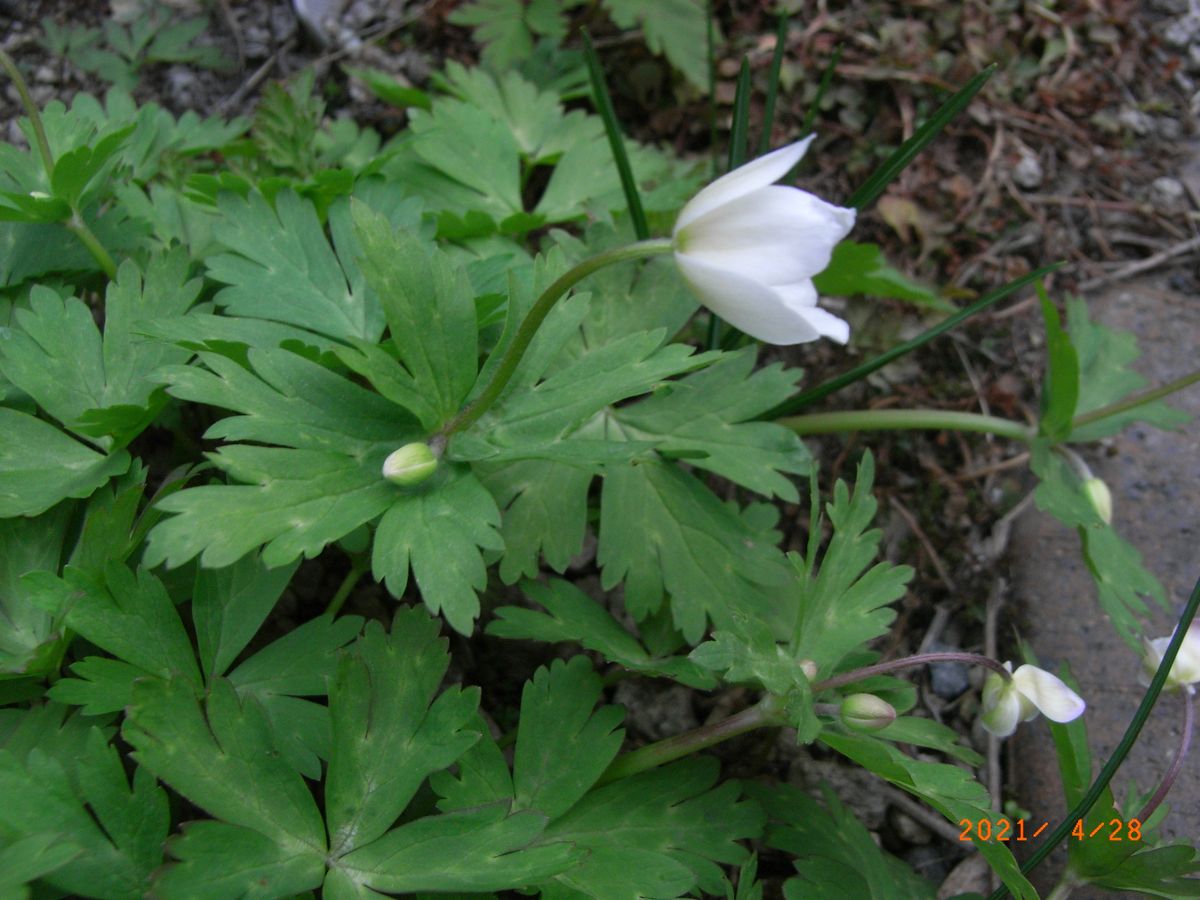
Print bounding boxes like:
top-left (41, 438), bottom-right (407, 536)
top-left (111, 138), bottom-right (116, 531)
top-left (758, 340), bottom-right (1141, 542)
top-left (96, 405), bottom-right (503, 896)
top-left (371, 468), bottom-right (504, 635)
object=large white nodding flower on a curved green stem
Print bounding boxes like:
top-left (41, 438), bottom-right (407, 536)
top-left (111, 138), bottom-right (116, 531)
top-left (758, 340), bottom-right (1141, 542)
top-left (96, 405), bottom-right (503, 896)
top-left (672, 137), bottom-right (856, 344)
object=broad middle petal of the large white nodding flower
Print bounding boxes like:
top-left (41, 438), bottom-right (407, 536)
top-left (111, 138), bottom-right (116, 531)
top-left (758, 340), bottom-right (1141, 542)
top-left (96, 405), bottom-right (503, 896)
top-left (676, 185), bottom-right (856, 284)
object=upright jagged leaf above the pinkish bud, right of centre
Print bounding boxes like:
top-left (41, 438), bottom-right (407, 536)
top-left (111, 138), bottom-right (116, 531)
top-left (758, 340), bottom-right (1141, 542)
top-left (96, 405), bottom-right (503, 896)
top-left (792, 452), bottom-right (913, 672)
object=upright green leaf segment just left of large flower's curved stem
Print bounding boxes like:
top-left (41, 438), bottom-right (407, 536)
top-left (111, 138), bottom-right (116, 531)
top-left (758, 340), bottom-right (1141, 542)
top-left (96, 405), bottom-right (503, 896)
top-left (354, 205), bottom-right (478, 425)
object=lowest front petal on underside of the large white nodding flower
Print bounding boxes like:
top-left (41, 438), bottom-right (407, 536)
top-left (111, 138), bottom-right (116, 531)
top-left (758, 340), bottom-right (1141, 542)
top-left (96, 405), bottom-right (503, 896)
top-left (676, 253), bottom-right (821, 344)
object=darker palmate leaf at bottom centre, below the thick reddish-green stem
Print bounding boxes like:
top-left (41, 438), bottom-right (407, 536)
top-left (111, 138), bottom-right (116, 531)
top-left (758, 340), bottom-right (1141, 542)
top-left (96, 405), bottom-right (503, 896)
top-left (431, 658), bottom-right (762, 900)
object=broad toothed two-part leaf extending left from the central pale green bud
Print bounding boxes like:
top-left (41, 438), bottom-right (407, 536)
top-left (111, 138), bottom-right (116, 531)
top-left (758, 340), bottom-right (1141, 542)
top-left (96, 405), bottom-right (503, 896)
top-left (146, 340), bottom-right (418, 566)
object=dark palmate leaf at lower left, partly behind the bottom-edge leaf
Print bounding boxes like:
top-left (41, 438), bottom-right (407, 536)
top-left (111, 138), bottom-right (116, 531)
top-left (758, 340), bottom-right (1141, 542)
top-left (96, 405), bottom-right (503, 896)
top-left (41, 557), bottom-right (361, 778)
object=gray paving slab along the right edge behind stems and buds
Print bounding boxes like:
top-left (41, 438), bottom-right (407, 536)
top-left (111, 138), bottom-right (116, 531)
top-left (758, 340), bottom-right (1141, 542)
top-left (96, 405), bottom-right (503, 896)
top-left (1009, 276), bottom-right (1200, 896)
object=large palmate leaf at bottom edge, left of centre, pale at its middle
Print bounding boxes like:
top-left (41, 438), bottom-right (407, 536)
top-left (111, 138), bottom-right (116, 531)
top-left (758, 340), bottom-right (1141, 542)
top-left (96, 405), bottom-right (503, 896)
top-left (125, 610), bottom-right (580, 898)
